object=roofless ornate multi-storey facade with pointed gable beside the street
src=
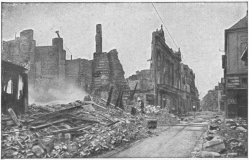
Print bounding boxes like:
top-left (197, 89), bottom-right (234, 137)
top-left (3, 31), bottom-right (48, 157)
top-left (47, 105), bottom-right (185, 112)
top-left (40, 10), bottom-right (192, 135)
top-left (128, 27), bottom-right (200, 113)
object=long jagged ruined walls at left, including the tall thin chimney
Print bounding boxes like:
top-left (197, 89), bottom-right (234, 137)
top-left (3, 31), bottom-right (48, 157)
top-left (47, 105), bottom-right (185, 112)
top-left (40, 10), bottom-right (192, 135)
top-left (2, 24), bottom-right (129, 104)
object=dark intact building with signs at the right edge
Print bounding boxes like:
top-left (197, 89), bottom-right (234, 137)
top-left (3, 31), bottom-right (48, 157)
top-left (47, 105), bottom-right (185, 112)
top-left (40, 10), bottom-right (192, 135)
top-left (222, 14), bottom-right (248, 118)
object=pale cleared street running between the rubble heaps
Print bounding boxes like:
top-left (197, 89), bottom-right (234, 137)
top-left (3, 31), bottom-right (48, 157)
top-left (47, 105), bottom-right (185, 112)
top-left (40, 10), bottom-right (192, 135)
top-left (100, 112), bottom-right (213, 158)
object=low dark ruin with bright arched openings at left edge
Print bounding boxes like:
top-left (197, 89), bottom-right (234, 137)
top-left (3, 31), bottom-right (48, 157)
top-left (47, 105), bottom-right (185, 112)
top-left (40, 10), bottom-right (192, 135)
top-left (1, 60), bottom-right (28, 114)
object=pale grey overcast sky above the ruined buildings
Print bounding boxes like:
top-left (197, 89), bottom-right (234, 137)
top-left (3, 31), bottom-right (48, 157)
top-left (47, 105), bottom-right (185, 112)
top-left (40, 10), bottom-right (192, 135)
top-left (2, 2), bottom-right (247, 98)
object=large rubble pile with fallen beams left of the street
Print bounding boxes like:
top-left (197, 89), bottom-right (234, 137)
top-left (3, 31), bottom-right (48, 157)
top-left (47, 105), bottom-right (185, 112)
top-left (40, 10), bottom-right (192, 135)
top-left (1, 101), bottom-right (153, 158)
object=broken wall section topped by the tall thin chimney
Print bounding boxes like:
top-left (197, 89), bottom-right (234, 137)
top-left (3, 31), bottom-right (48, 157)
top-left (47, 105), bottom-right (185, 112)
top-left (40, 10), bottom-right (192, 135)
top-left (92, 24), bottom-right (129, 100)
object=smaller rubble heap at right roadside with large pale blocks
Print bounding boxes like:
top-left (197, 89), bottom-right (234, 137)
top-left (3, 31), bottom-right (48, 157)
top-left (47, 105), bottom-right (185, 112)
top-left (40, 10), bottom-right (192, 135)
top-left (193, 116), bottom-right (248, 158)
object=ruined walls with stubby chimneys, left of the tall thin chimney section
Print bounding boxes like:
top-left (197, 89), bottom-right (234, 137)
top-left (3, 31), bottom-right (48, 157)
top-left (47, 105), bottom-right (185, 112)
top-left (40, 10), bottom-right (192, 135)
top-left (2, 30), bottom-right (91, 95)
